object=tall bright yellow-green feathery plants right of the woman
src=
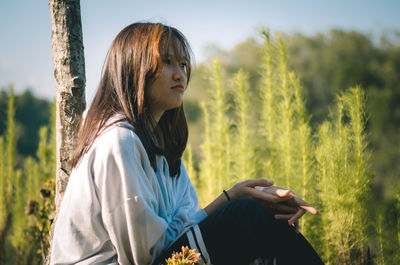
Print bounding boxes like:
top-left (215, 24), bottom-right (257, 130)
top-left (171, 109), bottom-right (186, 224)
top-left (196, 32), bottom-right (378, 264)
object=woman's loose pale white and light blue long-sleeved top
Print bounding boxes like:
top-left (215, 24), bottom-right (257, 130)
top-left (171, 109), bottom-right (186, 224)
top-left (51, 117), bottom-right (207, 265)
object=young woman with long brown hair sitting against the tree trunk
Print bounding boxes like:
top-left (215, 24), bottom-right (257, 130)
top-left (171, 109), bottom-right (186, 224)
top-left (51, 23), bottom-right (322, 265)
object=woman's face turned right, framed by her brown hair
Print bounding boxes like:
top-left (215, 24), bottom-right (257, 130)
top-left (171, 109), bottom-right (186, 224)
top-left (147, 45), bottom-right (187, 122)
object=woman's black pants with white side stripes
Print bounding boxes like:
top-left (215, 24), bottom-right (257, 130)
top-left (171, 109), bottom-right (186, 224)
top-left (155, 199), bottom-right (324, 265)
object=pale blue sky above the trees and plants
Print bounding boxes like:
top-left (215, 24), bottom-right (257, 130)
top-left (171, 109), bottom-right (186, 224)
top-left (0, 0), bottom-right (400, 102)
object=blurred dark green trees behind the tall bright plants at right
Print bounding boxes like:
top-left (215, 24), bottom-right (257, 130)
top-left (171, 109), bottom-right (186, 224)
top-left (187, 29), bottom-right (400, 196)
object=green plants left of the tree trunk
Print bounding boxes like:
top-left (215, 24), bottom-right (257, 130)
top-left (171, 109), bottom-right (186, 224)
top-left (0, 86), bottom-right (55, 264)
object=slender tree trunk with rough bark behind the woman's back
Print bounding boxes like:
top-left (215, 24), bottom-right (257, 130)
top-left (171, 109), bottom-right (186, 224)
top-left (46, 0), bottom-right (86, 264)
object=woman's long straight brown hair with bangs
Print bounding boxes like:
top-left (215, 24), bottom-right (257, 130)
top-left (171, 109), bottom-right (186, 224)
top-left (71, 23), bottom-right (192, 177)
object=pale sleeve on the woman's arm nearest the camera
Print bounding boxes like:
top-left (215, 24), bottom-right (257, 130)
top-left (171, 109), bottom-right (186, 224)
top-left (93, 128), bottom-right (168, 265)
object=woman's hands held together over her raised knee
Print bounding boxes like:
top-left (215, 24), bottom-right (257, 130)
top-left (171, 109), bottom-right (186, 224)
top-left (228, 179), bottom-right (318, 232)
